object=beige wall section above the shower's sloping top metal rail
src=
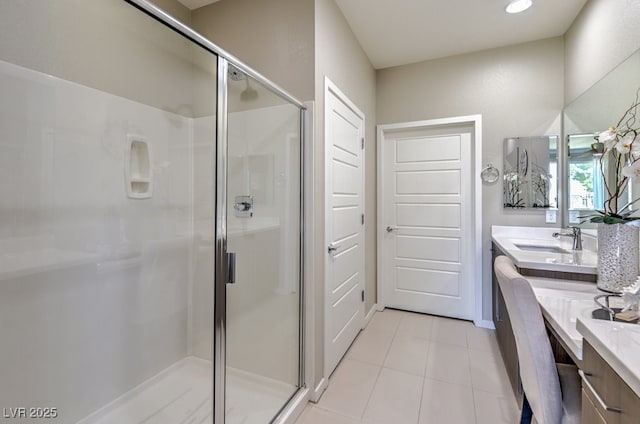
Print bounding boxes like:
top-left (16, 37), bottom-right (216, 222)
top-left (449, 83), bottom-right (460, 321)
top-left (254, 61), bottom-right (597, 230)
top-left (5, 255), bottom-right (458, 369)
top-left (192, 0), bottom-right (314, 101)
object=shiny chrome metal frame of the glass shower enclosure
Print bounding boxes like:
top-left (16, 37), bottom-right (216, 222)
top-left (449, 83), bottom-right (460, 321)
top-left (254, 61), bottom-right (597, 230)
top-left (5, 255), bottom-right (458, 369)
top-left (123, 0), bottom-right (308, 424)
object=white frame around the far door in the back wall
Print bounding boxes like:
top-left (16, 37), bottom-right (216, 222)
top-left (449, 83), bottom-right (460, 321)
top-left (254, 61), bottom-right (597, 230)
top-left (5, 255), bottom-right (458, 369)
top-left (376, 114), bottom-right (486, 327)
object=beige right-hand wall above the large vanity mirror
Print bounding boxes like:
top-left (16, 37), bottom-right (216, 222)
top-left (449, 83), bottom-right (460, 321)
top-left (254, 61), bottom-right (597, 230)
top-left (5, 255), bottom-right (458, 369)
top-left (565, 0), bottom-right (640, 104)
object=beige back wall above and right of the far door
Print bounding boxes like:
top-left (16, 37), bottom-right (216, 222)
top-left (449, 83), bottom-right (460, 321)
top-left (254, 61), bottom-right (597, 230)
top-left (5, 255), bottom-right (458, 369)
top-left (377, 37), bottom-right (564, 320)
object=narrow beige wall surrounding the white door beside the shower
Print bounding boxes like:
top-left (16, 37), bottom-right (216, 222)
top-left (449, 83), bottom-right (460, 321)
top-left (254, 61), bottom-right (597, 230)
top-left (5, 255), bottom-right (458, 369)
top-left (314, 0), bottom-right (376, 384)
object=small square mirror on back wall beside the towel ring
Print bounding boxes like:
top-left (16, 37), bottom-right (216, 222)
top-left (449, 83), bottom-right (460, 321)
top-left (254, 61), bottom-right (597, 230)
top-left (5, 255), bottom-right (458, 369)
top-left (503, 135), bottom-right (558, 209)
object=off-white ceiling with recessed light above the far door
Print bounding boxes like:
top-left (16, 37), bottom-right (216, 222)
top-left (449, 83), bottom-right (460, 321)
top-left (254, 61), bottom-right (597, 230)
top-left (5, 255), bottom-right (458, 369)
top-left (179, 0), bottom-right (587, 69)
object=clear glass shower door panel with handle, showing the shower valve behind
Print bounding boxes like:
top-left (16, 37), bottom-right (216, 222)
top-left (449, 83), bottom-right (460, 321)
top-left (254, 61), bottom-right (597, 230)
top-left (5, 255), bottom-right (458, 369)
top-left (217, 60), bottom-right (301, 424)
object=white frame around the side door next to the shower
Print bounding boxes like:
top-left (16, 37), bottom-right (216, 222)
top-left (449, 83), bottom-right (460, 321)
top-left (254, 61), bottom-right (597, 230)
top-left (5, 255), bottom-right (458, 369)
top-left (321, 76), bottom-right (367, 378)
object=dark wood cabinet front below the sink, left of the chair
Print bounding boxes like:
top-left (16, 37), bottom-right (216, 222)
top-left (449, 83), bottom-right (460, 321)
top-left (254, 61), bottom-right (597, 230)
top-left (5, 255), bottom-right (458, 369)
top-left (491, 244), bottom-right (522, 399)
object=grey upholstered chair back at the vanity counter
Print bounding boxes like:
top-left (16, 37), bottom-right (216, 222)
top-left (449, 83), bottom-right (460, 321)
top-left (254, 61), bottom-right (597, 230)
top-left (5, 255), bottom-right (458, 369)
top-left (494, 256), bottom-right (563, 424)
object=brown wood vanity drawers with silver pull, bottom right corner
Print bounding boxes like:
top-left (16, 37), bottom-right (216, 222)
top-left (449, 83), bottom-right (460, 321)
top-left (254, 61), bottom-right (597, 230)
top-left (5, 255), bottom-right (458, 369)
top-left (582, 340), bottom-right (640, 424)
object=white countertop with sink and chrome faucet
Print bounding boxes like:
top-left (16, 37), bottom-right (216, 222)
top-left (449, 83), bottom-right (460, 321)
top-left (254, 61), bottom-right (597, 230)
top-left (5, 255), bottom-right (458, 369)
top-left (491, 225), bottom-right (598, 274)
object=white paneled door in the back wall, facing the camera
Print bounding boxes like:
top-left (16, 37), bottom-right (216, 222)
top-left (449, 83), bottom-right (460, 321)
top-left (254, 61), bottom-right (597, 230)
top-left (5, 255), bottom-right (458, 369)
top-left (378, 121), bottom-right (479, 319)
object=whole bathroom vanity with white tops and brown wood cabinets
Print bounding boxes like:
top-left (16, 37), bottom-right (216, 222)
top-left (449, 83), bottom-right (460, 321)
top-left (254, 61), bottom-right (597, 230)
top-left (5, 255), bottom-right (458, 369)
top-left (492, 226), bottom-right (640, 424)
